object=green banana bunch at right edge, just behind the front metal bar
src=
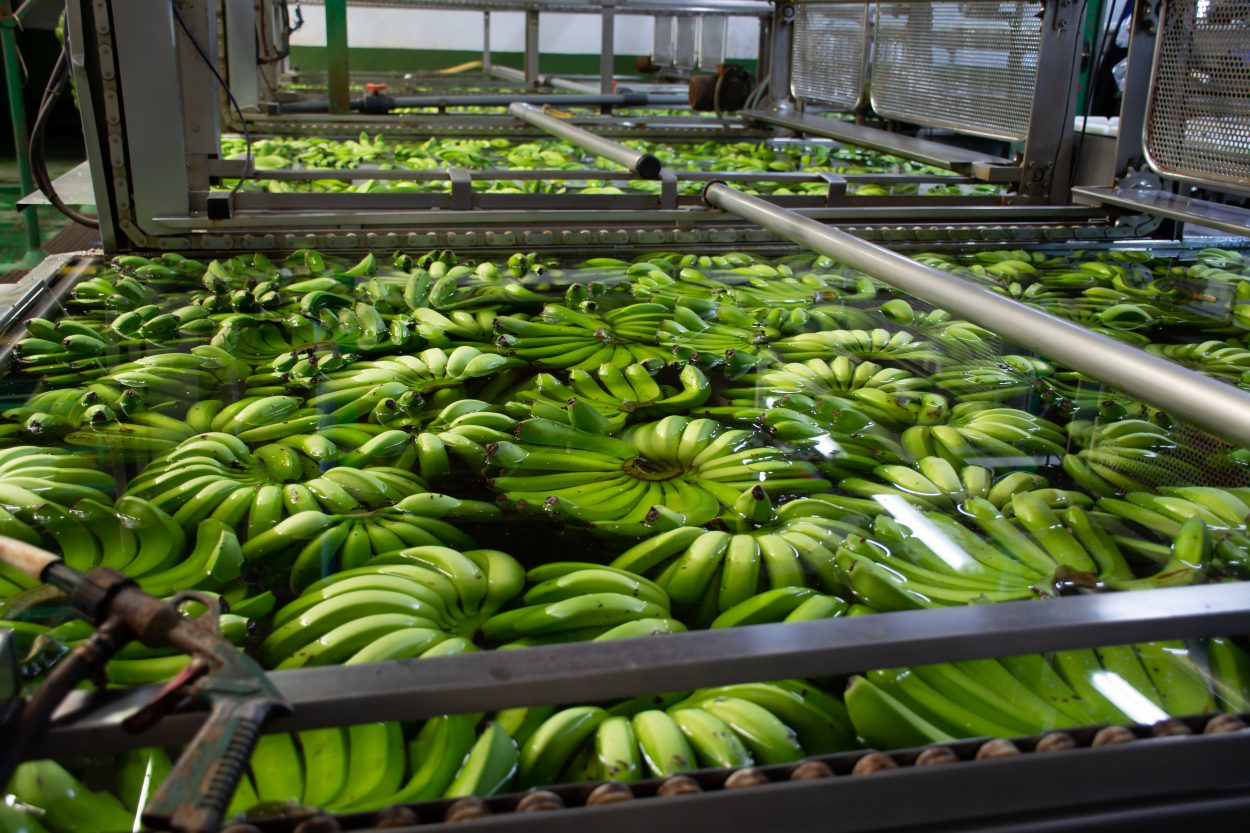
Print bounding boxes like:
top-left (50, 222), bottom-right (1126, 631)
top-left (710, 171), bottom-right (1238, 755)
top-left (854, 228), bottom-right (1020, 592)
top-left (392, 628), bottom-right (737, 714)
top-left (1098, 487), bottom-right (1250, 577)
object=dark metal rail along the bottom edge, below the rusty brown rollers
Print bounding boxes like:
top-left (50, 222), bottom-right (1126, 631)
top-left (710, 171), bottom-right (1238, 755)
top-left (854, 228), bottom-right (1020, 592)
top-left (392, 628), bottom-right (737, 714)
top-left (320, 729), bottom-right (1250, 833)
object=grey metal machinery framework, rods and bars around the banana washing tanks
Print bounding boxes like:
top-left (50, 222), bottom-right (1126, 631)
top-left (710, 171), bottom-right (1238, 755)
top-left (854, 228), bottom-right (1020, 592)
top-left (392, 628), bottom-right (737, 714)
top-left (0, 0), bottom-right (1250, 832)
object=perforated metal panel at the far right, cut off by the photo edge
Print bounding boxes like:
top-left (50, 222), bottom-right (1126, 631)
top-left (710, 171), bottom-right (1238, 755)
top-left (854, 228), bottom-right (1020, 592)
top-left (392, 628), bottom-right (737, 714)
top-left (1145, 0), bottom-right (1250, 190)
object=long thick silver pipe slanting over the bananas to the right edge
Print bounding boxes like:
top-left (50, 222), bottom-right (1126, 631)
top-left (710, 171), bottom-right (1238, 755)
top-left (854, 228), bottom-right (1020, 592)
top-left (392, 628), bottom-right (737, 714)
top-left (704, 183), bottom-right (1250, 448)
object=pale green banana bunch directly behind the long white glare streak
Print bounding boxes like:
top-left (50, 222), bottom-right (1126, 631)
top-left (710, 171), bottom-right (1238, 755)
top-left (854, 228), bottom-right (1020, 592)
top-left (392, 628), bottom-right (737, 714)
top-left (838, 457), bottom-right (1093, 514)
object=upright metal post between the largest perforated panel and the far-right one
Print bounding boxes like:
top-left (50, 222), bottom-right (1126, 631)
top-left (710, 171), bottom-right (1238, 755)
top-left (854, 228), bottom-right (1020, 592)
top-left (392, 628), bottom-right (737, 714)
top-left (1020, 0), bottom-right (1085, 205)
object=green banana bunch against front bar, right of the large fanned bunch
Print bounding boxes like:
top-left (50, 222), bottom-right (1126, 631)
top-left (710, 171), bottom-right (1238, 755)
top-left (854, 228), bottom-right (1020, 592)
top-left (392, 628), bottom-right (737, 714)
top-left (481, 562), bottom-right (686, 648)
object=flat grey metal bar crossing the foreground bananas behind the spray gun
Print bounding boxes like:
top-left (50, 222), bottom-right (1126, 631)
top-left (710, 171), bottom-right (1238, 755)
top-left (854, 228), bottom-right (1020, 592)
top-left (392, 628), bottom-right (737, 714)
top-left (40, 584), bottom-right (1250, 757)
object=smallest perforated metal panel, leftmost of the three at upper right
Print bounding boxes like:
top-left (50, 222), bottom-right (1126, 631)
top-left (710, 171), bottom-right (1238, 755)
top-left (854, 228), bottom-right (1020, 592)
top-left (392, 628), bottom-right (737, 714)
top-left (790, 3), bottom-right (868, 110)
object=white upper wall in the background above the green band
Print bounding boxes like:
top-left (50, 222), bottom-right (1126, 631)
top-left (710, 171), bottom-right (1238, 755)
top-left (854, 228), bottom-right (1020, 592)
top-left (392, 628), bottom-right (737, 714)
top-left (291, 5), bottom-right (759, 59)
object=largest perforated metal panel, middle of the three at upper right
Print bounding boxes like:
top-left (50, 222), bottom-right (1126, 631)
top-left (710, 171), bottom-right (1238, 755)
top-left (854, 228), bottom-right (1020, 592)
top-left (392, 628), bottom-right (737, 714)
top-left (873, 0), bottom-right (1045, 141)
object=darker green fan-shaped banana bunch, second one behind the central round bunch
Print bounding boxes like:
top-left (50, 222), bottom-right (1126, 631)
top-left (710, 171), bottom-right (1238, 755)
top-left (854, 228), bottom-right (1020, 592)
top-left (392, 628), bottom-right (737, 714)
top-left (495, 296), bottom-right (673, 370)
